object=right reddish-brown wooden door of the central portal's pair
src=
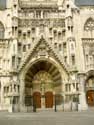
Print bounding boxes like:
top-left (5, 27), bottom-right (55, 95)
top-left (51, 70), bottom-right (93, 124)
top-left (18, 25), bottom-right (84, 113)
top-left (45, 92), bottom-right (53, 108)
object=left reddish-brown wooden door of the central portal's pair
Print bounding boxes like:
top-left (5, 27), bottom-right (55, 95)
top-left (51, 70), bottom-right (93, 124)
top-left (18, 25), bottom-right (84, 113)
top-left (33, 92), bottom-right (41, 108)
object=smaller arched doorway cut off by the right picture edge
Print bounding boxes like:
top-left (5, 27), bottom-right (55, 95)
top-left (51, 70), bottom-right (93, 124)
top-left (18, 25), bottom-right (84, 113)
top-left (86, 76), bottom-right (94, 106)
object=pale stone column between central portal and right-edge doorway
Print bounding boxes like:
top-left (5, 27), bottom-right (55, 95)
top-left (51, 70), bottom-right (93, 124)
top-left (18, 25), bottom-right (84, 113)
top-left (78, 73), bottom-right (88, 110)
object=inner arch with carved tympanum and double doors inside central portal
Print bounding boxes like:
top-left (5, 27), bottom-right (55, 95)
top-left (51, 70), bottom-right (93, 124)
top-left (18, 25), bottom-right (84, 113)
top-left (32, 70), bottom-right (54, 108)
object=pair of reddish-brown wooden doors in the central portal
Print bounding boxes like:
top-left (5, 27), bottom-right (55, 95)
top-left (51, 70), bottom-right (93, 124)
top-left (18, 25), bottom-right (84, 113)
top-left (33, 92), bottom-right (53, 108)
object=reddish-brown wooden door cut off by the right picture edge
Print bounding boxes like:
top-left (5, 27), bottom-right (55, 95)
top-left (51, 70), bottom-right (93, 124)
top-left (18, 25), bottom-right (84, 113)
top-left (87, 90), bottom-right (94, 106)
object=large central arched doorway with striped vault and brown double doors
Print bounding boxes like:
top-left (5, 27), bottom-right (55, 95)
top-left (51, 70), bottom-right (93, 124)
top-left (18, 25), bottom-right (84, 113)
top-left (25, 61), bottom-right (62, 108)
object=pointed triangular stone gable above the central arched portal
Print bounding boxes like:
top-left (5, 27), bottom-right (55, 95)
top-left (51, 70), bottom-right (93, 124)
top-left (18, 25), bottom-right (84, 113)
top-left (19, 37), bottom-right (68, 81)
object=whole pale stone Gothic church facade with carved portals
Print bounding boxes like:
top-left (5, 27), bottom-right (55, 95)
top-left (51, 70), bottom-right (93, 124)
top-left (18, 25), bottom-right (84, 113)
top-left (0, 0), bottom-right (94, 112)
